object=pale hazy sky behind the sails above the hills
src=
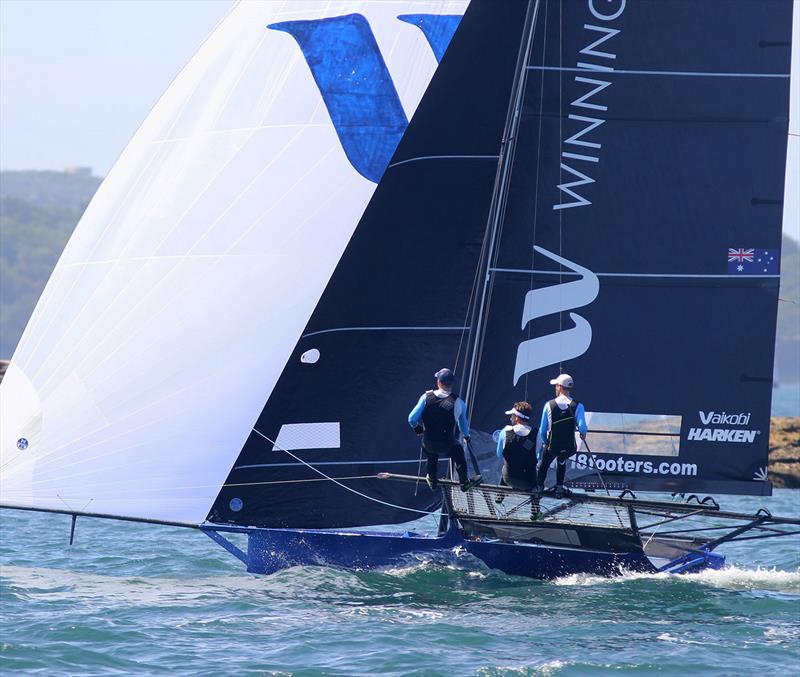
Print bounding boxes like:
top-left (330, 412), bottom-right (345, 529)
top-left (0, 0), bottom-right (800, 239)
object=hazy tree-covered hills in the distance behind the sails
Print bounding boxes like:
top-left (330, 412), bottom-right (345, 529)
top-left (0, 171), bottom-right (800, 383)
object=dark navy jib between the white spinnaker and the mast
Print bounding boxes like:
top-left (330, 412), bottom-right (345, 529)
top-left (208, 0), bottom-right (528, 528)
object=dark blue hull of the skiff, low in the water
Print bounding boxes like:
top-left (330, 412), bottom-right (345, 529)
top-left (225, 529), bottom-right (724, 579)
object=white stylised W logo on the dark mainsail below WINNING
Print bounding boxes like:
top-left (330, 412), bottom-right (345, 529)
top-left (514, 246), bottom-right (600, 385)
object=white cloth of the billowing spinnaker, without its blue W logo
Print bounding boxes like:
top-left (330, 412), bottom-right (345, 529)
top-left (0, 0), bottom-right (468, 522)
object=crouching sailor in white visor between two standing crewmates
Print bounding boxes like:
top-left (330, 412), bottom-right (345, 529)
top-left (495, 402), bottom-right (539, 519)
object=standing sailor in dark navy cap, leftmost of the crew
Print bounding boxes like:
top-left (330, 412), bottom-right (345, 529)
top-left (408, 369), bottom-right (480, 491)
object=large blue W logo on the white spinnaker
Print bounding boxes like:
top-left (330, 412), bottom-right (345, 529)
top-left (267, 14), bottom-right (461, 183)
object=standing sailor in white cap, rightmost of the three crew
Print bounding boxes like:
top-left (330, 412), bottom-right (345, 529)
top-left (537, 374), bottom-right (588, 498)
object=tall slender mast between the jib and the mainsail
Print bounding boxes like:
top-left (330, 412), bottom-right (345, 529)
top-left (464, 0), bottom-right (540, 414)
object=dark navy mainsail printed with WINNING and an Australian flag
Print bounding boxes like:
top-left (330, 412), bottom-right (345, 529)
top-left (468, 0), bottom-right (792, 494)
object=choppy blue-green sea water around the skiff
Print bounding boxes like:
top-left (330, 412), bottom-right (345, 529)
top-left (0, 490), bottom-right (800, 677)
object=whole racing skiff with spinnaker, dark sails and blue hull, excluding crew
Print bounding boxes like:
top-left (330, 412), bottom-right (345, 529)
top-left (0, 0), bottom-right (800, 578)
